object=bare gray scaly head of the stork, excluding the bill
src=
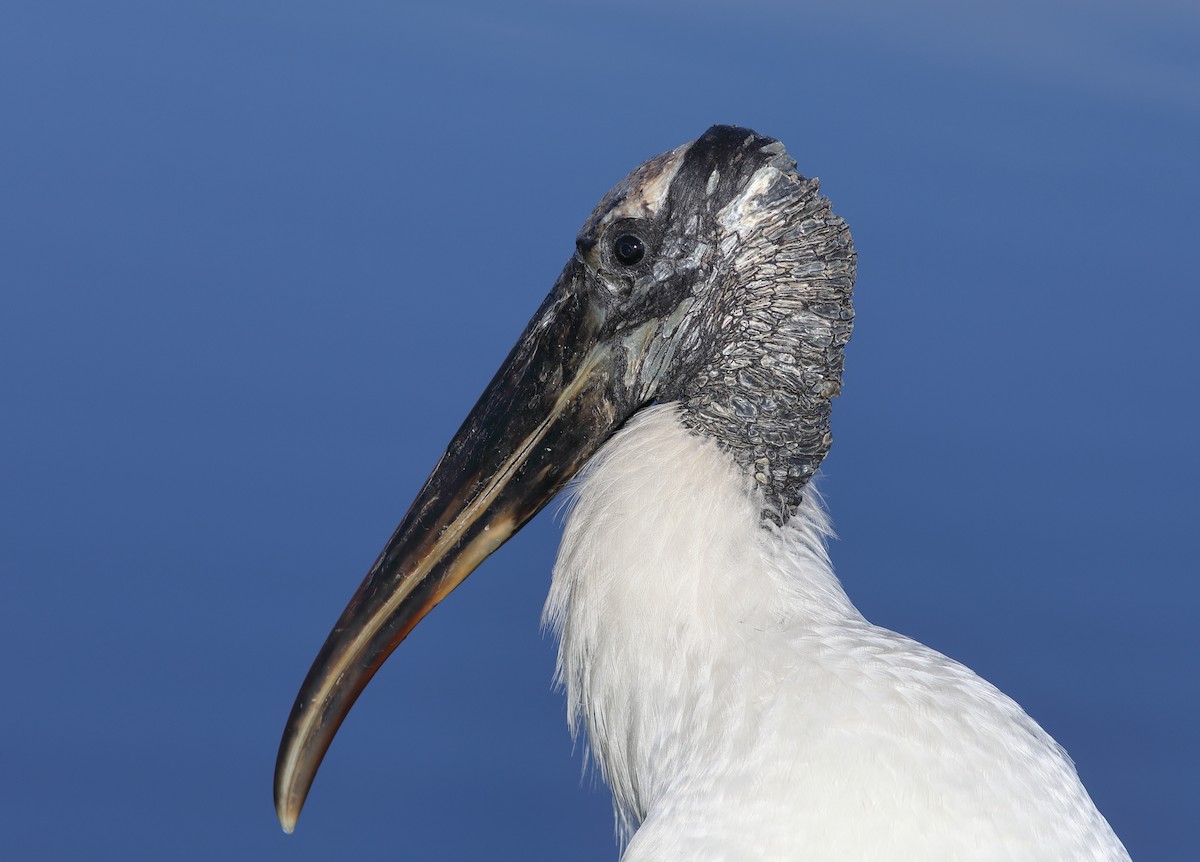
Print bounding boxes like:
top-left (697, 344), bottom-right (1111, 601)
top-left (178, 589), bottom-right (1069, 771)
top-left (578, 126), bottom-right (856, 523)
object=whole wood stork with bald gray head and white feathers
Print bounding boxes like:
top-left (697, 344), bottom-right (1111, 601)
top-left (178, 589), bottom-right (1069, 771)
top-left (275, 126), bottom-right (1128, 862)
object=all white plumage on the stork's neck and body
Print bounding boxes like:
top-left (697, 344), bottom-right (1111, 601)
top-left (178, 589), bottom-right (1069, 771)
top-left (546, 405), bottom-right (1129, 862)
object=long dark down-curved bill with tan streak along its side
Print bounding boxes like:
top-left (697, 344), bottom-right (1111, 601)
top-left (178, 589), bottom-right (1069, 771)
top-left (275, 259), bottom-right (631, 832)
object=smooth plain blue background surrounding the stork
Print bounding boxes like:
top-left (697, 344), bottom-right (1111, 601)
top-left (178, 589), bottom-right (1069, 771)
top-left (0, 0), bottom-right (1200, 860)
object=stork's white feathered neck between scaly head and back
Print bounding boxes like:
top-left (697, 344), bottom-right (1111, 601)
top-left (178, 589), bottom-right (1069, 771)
top-left (545, 405), bottom-right (862, 830)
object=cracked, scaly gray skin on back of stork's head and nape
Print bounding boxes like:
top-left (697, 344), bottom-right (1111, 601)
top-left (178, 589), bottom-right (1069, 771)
top-left (683, 158), bottom-right (856, 523)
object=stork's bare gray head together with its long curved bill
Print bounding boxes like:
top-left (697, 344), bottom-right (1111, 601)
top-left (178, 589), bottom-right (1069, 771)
top-left (275, 126), bottom-right (854, 832)
